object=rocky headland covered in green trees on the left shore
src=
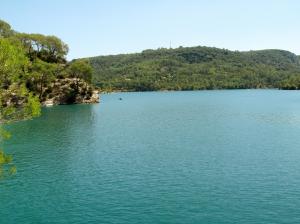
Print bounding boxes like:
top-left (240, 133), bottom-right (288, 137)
top-left (0, 20), bottom-right (96, 117)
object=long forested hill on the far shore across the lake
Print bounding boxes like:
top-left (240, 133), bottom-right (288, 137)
top-left (89, 47), bottom-right (300, 91)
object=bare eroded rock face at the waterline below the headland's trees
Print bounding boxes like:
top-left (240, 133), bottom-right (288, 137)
top-left (41, 78), bottom-right (99, 106)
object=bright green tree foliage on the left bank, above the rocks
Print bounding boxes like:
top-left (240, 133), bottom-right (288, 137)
top-left (0, 20), bottom-right (92, 177)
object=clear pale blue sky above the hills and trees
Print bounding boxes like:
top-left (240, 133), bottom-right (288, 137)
top-left (0, 0), bottom-right (300, 59)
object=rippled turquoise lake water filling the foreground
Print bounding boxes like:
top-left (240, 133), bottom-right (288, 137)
top-left (0, 90), bottom-right (300, 224)
